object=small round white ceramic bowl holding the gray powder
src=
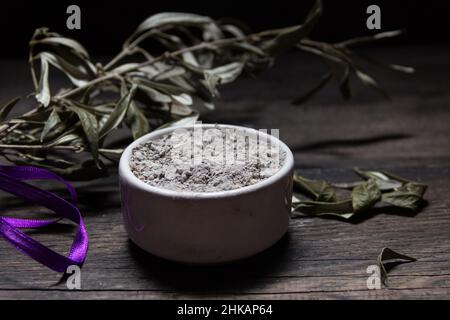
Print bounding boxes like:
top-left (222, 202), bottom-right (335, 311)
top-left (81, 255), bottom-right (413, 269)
top-left (119, 124), bottom-right (294, 263)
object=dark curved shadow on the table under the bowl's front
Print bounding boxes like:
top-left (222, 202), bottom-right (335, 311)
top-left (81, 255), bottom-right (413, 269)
top-left (129, 233), bottom-right (290, 293)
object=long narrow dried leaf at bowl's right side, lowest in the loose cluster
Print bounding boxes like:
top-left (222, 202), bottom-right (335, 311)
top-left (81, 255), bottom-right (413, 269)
top-left (291, 199), bottom-right (355, 219)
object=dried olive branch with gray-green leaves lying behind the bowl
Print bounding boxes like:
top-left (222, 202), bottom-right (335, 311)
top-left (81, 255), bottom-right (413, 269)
top-left (0, 1), bottom-right (414, 180)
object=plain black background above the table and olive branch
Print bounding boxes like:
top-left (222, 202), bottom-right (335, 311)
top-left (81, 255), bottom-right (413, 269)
top-left (0, 0), bottom-right (450, 58)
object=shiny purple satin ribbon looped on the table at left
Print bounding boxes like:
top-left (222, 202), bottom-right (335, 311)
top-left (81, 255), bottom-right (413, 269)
top-left (0, 165), bottom-right (88, 272)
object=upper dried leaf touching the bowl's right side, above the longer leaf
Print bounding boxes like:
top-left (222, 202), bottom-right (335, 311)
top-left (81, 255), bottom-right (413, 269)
top-left (293, 172), bottom-right (337, 202)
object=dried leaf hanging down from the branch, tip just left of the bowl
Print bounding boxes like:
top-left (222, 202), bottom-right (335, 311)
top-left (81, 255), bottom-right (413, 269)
top-left (67, 100), bottom-right (100, 164)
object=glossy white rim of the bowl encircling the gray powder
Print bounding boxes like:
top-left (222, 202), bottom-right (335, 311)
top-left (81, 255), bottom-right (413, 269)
top-left (119, 123), bottom-right (294, 199)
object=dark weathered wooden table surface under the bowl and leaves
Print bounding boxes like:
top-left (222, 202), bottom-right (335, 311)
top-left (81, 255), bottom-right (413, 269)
top-left (0, 47), bottom-right (450, 299)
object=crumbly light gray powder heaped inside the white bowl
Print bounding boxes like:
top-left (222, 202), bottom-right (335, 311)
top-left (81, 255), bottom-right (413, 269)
top-left (130, 127), bottom-right (286, 192)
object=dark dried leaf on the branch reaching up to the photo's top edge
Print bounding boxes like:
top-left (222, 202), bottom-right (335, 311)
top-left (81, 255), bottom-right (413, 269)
top-left (263, 0), bottom-right (322, 56)
